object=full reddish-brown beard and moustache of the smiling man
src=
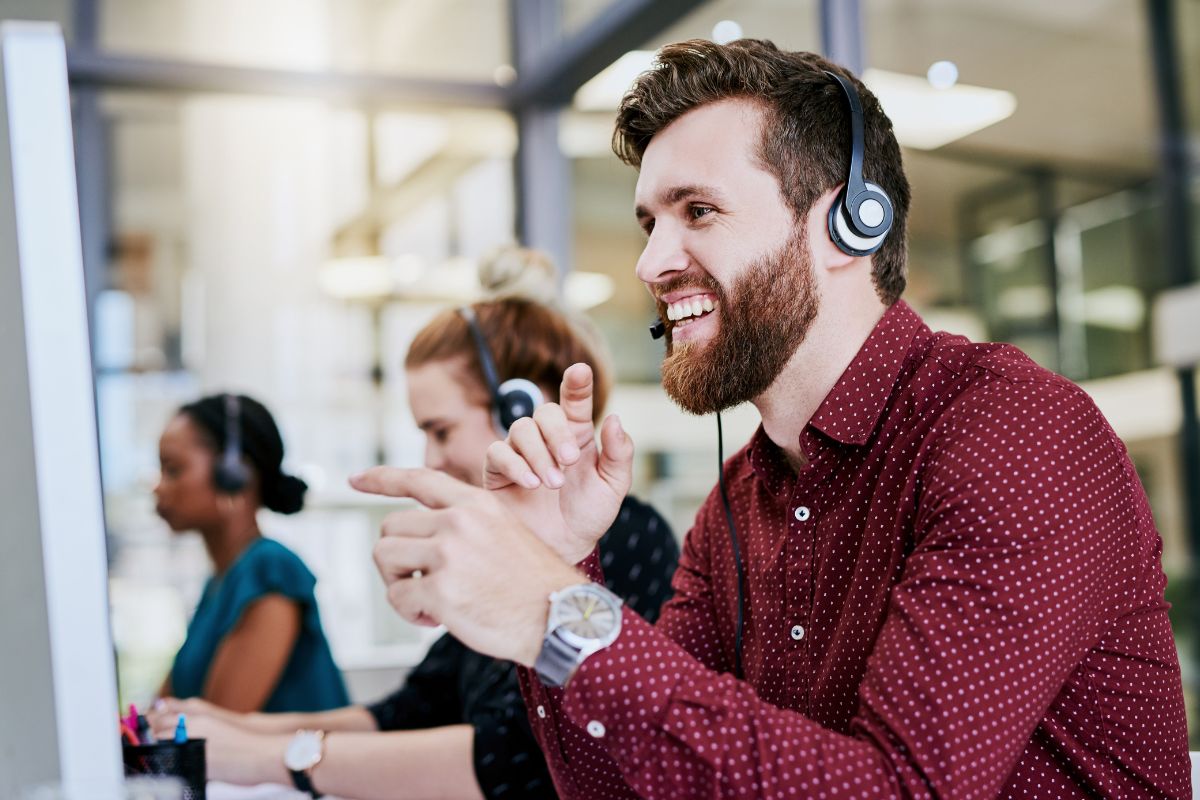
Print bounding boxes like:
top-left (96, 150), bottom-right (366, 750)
top-left (659, 234), bottom-right (820, 414)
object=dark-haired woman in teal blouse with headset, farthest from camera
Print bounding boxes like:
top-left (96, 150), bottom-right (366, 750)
top-left (154, 395), bottom-right (348, 711)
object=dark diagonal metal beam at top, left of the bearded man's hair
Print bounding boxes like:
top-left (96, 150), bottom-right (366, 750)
top-left (510, 0), bottom-right (708, 108)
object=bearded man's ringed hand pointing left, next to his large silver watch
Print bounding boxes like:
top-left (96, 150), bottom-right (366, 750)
top-left (350, 467), bottom-right (587, 666)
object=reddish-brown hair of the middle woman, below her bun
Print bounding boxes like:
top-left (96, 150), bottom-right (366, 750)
top-left (404, 297), bottom-right (610, 422)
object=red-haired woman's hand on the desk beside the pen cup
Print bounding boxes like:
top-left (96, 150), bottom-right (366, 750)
top-left (151, 712), bottom-right (292, 786)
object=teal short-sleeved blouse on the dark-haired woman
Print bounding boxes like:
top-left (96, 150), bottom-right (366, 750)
top-left (170, 537), bottom-right (350, 711)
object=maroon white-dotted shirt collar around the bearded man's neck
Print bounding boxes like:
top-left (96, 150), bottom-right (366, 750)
top-left (746, 300), bottom-right (930, 494)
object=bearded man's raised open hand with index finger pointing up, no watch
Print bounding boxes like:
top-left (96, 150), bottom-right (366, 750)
top-left (484, 363), bottom-right (634, 564)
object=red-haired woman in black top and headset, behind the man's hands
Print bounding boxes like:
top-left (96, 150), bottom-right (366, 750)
top-left (148, 249), bottom-right (679, 800)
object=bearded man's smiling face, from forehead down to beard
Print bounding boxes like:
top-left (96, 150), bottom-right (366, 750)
top-left (635, 100), bottom-right (817, 414)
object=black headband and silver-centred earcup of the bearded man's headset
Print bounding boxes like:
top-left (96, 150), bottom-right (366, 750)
top-left (826, 70), bottom-right (893, 255)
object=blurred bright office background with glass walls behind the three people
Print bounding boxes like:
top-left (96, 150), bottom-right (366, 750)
top-left (0, 0), bottom-right (1200, 744)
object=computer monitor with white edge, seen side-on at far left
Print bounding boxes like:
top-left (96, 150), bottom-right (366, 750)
top-left (0, 23), bottom-right (121, 800)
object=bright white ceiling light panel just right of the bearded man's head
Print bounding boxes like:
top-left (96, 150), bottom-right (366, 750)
top-left (863, 70), bottom-right (1016, 150)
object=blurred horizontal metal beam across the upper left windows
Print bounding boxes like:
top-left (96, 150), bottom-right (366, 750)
top-left (67, 49), bottom-right (506, 108)
